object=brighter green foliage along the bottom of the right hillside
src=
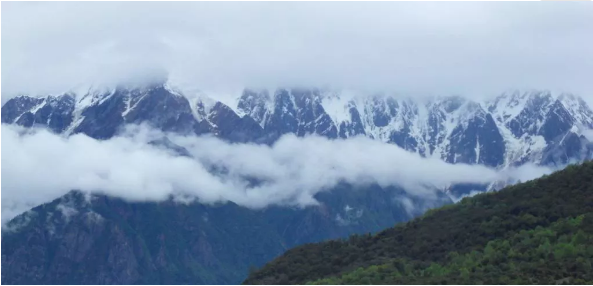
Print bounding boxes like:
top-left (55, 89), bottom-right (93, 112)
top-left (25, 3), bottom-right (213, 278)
top-left (313, 214), bottom-right (593, 284)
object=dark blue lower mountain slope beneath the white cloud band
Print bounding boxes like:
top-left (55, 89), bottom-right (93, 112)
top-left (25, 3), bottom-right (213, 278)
top-left (2, 183), bottom-right (451, 284)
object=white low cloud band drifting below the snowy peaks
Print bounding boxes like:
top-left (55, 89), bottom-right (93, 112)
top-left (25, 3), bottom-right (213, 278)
top-left (2, 125), bottom-right (551, 224)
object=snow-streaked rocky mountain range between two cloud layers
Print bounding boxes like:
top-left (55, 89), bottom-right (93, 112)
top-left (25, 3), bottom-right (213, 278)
top-left (2, 80), bottom-right (593, 168)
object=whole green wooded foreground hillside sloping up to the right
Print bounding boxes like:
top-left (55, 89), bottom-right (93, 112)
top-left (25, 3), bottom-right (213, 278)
top-left (244, 161), bottom-right (593, 284)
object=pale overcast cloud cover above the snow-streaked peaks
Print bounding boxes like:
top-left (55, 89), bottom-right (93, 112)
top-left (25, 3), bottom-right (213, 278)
top-left (2, 2), bottom-right (593, 102)
